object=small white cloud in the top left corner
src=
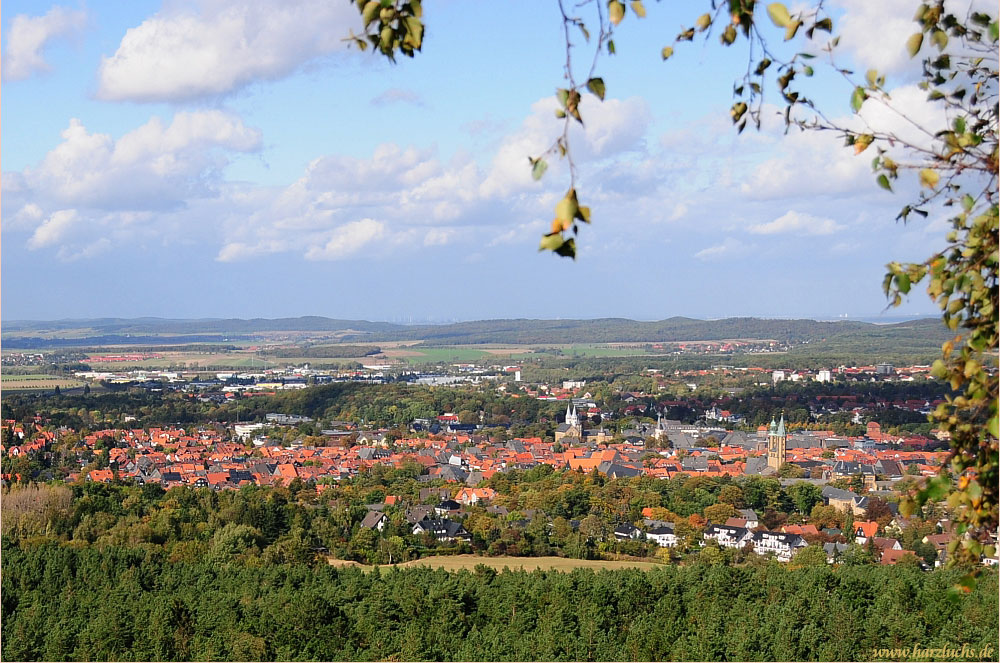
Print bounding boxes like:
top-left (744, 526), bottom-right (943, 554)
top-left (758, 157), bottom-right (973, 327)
top-left (3, 7), bottom-right (87, 80)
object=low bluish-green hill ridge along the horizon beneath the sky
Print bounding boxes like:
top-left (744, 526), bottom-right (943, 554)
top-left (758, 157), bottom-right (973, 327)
top-left (3, 316), bottom-right (949, 347)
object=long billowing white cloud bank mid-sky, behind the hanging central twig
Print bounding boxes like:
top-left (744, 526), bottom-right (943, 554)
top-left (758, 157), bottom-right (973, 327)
top-left (218, 94), bottom-right (648, 261)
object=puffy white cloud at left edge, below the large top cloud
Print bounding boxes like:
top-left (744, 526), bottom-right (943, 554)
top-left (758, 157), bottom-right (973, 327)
top-left (3, 111), bottom-right (260, 260)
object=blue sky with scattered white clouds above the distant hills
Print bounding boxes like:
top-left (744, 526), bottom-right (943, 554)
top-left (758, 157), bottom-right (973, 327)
top-left (0, 0), bottom-right (996, 321)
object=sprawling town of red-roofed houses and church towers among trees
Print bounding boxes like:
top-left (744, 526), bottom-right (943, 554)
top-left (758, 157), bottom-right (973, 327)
top-left (2, 364), bottom-right (984, 569)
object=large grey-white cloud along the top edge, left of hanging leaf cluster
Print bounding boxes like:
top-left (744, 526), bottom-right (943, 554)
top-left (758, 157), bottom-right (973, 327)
top-left (98, 0), bottom-right (361, 101)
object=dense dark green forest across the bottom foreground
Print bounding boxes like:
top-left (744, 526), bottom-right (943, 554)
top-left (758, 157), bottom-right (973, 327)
top-left (2, 544), bottom-right (997, 661)
